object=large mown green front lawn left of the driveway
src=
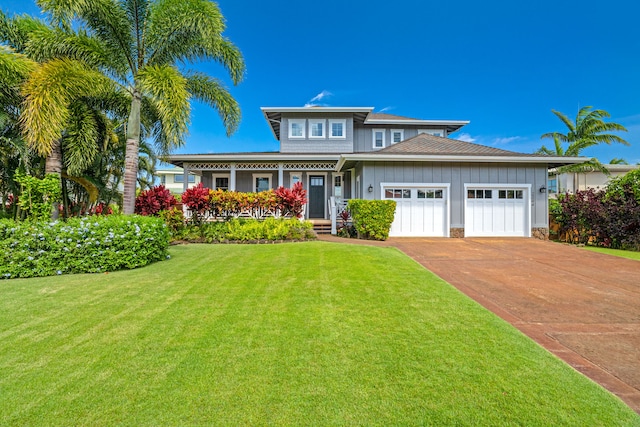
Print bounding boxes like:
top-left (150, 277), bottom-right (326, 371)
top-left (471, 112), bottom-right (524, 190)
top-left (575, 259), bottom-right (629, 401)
top-left (0, 242), bottom-right (640, 426)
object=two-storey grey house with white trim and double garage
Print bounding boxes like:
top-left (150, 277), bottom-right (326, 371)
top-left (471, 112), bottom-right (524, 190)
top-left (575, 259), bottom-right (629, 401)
top-left (169, 107), bottom-right (585, 238)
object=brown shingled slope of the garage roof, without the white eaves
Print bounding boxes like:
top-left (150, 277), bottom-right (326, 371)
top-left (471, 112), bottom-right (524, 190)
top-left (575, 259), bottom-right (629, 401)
top-left (372, 133), bottom-right (529, 156)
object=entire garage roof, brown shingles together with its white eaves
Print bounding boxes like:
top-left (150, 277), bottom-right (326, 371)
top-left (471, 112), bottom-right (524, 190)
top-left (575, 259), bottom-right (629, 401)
top-left (336, 134), bottom-right (587, 170)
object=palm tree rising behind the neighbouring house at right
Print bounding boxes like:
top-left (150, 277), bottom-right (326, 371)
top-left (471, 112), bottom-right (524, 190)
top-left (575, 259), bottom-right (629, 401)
top-left (537, 106), bottom-right (629, 173)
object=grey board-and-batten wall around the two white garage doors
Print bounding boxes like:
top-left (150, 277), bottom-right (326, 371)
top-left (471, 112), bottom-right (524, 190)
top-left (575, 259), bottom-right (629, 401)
top-left (356, 161), bottom-right (548, 228)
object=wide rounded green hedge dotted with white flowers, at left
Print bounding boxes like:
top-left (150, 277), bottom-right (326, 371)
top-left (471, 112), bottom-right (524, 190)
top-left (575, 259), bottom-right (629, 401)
top-left (0, 215), bottom-right (169, 279)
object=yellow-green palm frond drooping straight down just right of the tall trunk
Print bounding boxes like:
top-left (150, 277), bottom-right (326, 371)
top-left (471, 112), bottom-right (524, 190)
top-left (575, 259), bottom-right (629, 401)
top-left (138, 61), bottom-right (191, 153)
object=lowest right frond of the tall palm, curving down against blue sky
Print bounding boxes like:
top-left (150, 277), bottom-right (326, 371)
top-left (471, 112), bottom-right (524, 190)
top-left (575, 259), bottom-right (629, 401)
top-left (187, 73), bottom-right (242, 136)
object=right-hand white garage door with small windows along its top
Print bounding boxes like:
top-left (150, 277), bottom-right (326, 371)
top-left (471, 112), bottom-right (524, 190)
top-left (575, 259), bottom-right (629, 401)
top-left (464, 186), bottom-right (531, 237)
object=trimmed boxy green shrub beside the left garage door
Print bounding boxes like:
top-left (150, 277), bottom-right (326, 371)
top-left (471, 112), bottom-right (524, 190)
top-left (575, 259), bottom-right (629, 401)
top-left (347, 199), bottom-right (396, 240)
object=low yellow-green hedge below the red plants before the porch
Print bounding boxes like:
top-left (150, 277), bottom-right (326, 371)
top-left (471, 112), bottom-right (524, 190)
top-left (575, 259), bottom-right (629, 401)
top-left (196, 218), bottom-right (315, 243)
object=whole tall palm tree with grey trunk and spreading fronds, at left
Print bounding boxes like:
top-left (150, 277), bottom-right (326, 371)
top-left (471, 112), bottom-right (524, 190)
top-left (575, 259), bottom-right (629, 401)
top-left (29, 0), bottom-right (245, 214)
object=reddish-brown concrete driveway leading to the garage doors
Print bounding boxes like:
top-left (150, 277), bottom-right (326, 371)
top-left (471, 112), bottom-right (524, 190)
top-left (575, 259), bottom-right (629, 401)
top-left (322, 237), bottom-right (640, 413)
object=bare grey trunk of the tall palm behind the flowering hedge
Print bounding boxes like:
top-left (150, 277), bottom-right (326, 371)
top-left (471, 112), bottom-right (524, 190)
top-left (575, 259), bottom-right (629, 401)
top-left (122, 89), bottom-right (142, 215)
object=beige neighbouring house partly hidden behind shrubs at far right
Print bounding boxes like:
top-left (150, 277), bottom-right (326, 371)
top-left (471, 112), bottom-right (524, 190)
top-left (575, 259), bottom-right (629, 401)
top-left (548, 165), bottom-right (640, 197)
